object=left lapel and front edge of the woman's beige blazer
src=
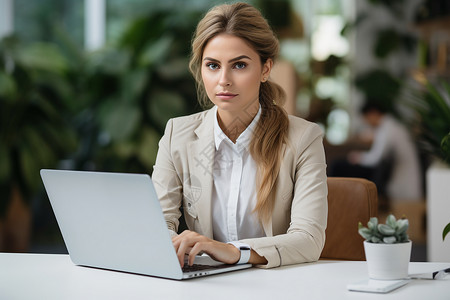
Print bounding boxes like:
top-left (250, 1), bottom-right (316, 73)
top-left (188, 109), bottom-right (215, 238)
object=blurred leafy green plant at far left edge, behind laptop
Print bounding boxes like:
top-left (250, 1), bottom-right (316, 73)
top-left (0, 37), bottom-right (76, 217)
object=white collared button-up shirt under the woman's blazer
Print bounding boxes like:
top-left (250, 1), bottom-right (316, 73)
top-left (212, 107), bottom-right (265, 242)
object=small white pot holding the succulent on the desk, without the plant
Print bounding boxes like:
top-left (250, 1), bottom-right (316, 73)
top-left (364, 241), bottom-right (412, 280)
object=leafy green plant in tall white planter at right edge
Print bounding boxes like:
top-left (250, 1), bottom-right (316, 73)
top-left (412, 80), bottom-right (450, 262)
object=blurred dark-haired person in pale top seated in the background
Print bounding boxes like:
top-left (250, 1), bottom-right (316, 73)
top-left (329, 100), bottom-right (423, 201)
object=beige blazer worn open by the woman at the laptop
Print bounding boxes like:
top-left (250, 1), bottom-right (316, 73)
top-left (152, 110), bottom-right (328, 268)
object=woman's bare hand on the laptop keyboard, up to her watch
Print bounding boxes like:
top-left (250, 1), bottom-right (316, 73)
top-left (172, 230), bottom-right (241, 267)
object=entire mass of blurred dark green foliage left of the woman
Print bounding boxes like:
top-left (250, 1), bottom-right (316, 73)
top-left (0, 7), bottom-right (205, 217)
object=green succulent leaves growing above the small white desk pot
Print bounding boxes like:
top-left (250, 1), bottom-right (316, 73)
top-left (358, 214), bottom-right (409, 244)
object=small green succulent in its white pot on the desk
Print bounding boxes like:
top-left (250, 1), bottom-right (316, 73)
top-left (358, 214), bottom-right (412, 280)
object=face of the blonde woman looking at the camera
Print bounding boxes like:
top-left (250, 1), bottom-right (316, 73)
top-left (201, 34), bottom-right (273, 114)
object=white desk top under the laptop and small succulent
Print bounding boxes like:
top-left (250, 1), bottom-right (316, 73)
top-left (0, 253), bottom-right (450, 300)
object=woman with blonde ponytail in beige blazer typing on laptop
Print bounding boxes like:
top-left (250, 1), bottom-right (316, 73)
top-left (152, 3), bottom-right (327, 268)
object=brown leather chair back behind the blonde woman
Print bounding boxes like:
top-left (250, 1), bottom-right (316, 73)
top-left (321, 177), bottom-right (378, 260)
